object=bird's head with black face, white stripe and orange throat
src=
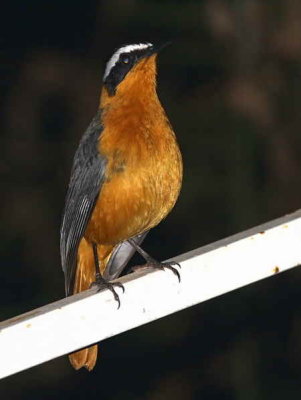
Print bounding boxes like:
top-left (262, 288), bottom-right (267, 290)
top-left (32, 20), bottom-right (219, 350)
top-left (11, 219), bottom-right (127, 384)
top-left (103, 43), bottom-right (165, 97)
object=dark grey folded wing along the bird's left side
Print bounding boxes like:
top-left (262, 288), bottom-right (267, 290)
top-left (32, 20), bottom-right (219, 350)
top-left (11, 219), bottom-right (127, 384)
top-left (60, 114), bottom-right (106, 296)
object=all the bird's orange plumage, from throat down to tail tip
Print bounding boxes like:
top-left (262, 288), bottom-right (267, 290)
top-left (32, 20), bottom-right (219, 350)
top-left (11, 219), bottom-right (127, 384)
top-left (61, 42), bottom-right (182, 370)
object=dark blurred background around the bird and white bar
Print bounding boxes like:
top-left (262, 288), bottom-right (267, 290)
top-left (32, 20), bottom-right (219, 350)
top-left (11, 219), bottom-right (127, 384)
top-left (0, 0), bottom-right (301, 400)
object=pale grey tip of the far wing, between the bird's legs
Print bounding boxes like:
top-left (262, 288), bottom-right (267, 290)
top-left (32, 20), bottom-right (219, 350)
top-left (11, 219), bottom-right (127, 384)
top-left (103, 231), bottom-right (149, 281)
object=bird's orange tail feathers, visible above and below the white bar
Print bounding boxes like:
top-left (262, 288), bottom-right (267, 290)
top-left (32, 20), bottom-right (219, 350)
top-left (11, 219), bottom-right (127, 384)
top-left (69, 238), bottom-right (112, 371)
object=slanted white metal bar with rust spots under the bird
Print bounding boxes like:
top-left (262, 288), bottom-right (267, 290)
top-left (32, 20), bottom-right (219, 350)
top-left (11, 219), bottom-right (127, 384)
top-left (0, 210), bottom-right (301, 377)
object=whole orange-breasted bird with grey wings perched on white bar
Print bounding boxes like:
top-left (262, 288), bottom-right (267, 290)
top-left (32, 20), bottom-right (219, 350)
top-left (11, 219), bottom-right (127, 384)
top-left (60, 42), bottom-right (183, 371)
